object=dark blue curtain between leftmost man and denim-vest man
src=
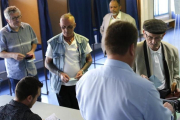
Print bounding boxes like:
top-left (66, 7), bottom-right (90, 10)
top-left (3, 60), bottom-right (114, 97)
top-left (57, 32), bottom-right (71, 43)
top-left (38, 0), bottom-right (53, 55)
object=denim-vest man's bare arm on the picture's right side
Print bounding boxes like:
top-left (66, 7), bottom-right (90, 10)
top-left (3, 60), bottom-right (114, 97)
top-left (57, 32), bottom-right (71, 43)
top-left (75, 53), bottom-right (92, 79)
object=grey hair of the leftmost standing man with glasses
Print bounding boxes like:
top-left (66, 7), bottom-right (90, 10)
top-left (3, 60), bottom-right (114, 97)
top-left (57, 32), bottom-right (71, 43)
top-left (4, 6), bottom-right (21, 20)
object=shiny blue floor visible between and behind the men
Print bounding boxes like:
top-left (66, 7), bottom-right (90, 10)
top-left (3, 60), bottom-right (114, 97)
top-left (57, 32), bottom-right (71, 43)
top-left (0, 29), bottom-right (180, 105)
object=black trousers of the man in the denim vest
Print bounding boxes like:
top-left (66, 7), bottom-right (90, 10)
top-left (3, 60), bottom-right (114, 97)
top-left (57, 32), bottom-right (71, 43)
top-left (56, 85), bottom-right (79, 110)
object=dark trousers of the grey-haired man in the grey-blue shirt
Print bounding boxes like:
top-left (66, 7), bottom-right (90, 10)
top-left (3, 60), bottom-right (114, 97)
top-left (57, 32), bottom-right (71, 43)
top-left (9, 75), bottom-right (41, 102)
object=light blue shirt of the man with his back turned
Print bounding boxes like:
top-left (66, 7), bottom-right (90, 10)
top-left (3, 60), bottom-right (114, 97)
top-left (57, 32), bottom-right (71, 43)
top-left (76, 59), bottom-right (171, 120)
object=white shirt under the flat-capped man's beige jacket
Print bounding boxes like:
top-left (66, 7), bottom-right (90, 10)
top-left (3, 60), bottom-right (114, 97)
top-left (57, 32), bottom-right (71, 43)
top-left (149, 46), bottom-right (165, 90)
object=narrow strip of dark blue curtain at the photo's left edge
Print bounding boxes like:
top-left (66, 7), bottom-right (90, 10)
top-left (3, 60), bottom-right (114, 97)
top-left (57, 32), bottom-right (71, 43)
top-left (1, 0), bottom-right (9, 27)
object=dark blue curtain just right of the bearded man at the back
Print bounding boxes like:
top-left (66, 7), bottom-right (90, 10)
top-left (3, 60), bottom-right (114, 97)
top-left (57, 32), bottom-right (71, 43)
top-left (126, 0), bottom-right (139, 30)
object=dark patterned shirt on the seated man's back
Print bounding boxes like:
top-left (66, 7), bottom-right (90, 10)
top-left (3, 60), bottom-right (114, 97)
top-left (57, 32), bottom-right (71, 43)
top-left (0, 100), bottom-right (42, 120)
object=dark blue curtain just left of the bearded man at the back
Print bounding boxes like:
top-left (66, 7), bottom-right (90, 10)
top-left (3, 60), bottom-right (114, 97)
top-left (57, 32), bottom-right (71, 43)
top-left (94, 0), bottom-right (110, 43)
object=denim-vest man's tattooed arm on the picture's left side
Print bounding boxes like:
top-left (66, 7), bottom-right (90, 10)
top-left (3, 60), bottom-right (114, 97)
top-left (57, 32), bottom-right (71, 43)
top-left (45, 57), bottom-right (70, 83)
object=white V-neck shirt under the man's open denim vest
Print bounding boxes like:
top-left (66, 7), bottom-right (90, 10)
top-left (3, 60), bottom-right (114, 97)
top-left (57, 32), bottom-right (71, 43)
top-left (46, 39), bottom-right (92, 86)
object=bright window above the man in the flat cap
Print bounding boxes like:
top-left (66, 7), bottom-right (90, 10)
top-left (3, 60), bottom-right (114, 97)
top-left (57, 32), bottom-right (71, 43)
top-left (154, 0), bottom-right (169, 17)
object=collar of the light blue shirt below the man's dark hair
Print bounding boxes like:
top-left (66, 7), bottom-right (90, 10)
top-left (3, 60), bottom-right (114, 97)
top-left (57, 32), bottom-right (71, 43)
top-left (104, 58), bottom-right (133, 72)
